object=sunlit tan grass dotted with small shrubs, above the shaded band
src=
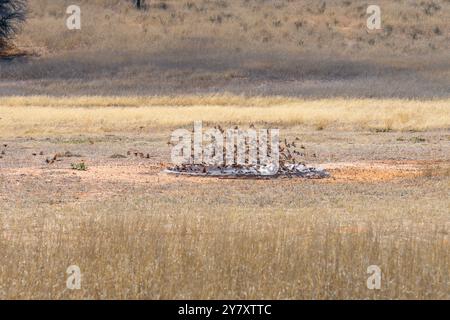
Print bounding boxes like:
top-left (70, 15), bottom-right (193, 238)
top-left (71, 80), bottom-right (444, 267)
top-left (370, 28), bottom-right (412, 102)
top-left (17, 0), bottom-right (450, 55)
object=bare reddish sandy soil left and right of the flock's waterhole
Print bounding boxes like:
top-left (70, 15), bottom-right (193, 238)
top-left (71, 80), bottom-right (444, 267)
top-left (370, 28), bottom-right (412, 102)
top-left (2, 161), bottom-right (442, 194)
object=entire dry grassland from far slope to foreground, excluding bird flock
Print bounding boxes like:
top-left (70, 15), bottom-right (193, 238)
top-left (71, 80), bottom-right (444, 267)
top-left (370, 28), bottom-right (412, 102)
top-left (0, 0), bottom-right (450, 299)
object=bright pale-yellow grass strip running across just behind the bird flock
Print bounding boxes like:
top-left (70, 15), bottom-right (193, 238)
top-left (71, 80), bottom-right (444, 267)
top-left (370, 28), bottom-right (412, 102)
top-left (0, 95), bottom-right (450, 136)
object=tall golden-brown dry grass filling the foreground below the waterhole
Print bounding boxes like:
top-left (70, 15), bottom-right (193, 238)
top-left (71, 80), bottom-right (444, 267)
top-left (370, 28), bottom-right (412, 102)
top-left (0, 165), bottom-right (450, 299)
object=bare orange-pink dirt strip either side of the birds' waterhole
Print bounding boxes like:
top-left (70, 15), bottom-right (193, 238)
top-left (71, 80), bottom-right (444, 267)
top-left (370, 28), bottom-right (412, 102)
top-left (1, 161), bottom-right (442, 201)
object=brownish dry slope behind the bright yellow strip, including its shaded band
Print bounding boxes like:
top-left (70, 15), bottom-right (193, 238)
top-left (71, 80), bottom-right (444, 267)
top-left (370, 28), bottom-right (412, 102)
top-left (0, 0), bottom-right (450, 99)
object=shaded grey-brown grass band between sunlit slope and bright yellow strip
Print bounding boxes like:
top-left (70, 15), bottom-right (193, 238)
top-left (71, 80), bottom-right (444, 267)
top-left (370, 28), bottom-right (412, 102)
top-left (0, 50), bottom-right (450, 99)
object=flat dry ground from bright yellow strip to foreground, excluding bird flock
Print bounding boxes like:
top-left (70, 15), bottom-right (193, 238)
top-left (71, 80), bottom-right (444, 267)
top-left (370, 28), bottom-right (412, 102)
top-left (0, 96), bottom-right (450, 299)
